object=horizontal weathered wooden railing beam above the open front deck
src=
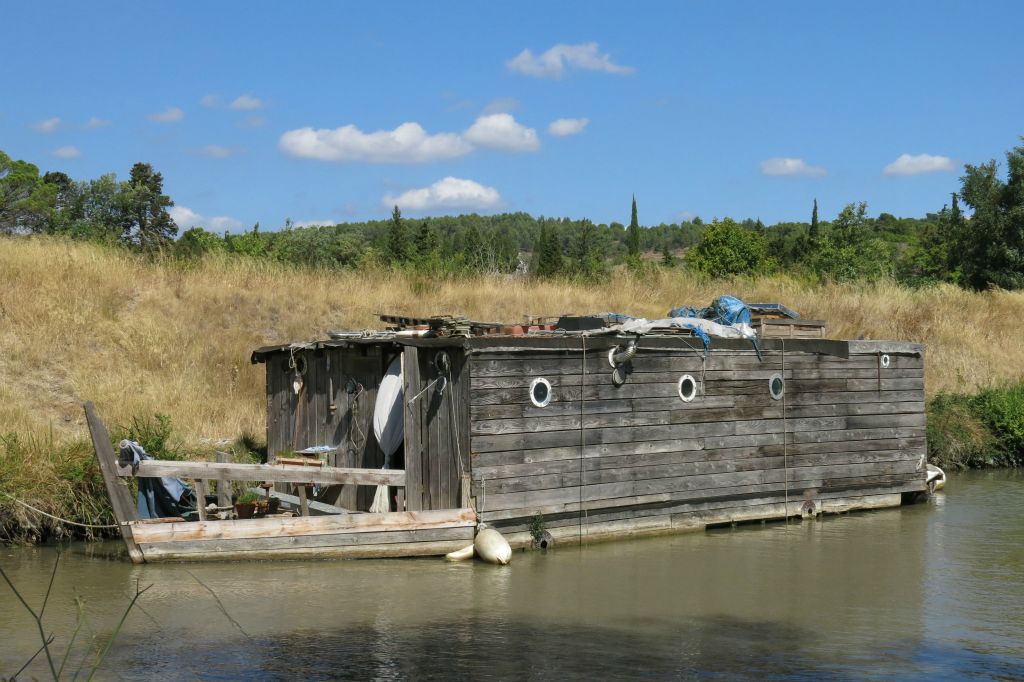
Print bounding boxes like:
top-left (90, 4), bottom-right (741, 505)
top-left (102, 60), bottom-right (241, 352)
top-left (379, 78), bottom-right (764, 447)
top-left (117, 460), bottom-right (406, 487)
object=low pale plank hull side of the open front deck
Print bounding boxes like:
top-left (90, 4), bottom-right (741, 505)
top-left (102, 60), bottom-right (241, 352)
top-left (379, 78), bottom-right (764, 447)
top-left (131, 509), bottom-right (476, 562)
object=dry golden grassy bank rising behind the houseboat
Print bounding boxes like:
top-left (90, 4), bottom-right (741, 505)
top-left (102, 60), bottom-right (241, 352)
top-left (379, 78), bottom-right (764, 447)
top-left (0, 239), bottom-right (1024, 532)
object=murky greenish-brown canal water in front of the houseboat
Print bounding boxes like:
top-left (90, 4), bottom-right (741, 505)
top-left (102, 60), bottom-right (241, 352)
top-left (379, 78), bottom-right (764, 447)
top-left (0, 472), bottom-right (1024, 680)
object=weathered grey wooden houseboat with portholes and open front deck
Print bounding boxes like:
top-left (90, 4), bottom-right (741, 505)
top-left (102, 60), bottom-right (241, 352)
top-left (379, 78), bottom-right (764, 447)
top-left (87, 309), bottom-right (926, 561)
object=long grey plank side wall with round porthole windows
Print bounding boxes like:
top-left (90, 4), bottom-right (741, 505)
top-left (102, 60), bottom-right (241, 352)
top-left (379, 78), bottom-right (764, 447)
top-left (469, 338), bottom-right (925, 531)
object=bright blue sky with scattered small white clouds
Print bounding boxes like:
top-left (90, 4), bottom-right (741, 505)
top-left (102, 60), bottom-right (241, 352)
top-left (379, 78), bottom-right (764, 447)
top-left (0, 0), bottom-right (1024, 229)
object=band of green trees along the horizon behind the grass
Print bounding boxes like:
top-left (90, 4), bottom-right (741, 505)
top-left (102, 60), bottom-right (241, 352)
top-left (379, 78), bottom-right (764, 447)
top-left (0, 137), bottom-right (1024, 289)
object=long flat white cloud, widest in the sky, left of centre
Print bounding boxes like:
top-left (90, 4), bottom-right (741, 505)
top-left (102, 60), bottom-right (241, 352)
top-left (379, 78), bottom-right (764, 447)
top-left (278, 123), bottom-right (472, 164)
